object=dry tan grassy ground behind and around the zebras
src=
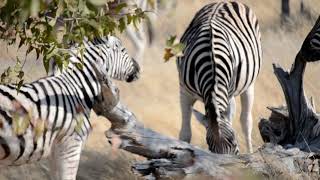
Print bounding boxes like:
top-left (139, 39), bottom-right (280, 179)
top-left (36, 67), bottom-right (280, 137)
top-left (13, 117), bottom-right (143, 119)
top-left (0, 0), bottom-right (320, 180)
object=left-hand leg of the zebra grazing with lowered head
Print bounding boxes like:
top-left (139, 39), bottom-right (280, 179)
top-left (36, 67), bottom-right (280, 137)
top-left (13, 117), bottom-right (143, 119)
top-left (179, 89), bottom-right (196, 143)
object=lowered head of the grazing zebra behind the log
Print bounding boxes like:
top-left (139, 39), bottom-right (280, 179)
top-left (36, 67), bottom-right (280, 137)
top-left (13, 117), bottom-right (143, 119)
top-left (193, 109), bottom-right (239, 154)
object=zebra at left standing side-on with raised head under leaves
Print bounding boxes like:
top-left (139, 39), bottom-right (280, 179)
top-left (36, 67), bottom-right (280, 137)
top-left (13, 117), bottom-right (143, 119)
top-left (0, 36), bottom-right (139, 179)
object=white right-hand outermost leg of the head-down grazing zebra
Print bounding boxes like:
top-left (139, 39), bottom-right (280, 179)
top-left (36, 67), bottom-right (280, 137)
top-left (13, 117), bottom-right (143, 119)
top-left (240, 84), bottom-right (254, 153)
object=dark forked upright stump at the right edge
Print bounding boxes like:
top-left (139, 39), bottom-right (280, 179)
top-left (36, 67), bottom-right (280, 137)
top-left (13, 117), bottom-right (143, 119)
top-left (259, 16), bottom-right (320, 153)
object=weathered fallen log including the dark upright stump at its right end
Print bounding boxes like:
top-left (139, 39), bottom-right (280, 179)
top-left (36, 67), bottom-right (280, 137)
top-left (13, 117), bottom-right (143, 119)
top-left (94, 18), bottom-right (320, 179)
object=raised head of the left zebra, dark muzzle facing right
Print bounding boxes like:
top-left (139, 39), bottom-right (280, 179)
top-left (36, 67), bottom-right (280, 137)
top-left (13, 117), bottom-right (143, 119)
top-left (89, 36), bottom-right (140, 82)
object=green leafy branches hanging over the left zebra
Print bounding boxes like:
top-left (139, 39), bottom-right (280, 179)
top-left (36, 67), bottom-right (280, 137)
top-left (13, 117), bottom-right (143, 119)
top-left (0, 0), bottom-right (146, 83)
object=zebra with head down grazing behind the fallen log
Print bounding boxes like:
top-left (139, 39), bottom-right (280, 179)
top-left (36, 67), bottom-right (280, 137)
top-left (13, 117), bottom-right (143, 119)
top-left (177, 2), bottom-right (261, 154)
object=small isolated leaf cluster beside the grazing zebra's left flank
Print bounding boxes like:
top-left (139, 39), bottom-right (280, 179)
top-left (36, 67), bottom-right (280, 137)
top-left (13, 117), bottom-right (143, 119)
top-left (163, 36), bottom-right (185, 62)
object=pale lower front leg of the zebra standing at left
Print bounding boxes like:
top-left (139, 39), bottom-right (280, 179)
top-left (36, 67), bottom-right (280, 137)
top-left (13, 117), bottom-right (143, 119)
top-left (50, 136), bottom-right (83, 180)
